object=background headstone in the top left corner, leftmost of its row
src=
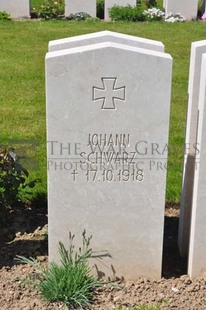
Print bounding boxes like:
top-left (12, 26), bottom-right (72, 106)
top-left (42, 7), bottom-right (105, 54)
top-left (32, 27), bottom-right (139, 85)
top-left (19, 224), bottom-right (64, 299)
top-left (0, 0), bottom-right (30, 18)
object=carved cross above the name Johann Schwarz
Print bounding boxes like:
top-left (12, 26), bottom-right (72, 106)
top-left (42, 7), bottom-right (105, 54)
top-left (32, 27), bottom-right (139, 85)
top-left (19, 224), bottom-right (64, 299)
top-left (92, 78), bottom-right (126, 110)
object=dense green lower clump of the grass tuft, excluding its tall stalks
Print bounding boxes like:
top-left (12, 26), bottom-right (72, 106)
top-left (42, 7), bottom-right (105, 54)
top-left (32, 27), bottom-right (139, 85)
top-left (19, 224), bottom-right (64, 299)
top-left (39, 263), bottom-right (97, 308)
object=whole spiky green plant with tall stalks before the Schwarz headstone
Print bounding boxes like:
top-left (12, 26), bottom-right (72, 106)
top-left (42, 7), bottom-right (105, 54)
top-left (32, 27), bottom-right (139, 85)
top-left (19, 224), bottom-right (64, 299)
top-left (17, 231), bottom-right (109, 308)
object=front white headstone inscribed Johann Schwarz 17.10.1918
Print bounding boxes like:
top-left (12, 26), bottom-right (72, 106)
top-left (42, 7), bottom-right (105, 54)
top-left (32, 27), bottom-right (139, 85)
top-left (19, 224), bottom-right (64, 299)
top-left (46, 37), bottom-right (172, 279)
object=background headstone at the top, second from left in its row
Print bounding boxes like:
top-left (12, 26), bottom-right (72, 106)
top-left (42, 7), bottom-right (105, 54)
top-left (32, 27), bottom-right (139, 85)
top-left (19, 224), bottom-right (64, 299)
top-left (65, 0), bottom-right (96, 17)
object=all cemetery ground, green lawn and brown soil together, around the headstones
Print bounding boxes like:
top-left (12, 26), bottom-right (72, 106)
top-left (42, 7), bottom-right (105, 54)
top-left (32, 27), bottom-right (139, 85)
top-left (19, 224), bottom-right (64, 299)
top-left (0, 21), bottom-right (206, 310)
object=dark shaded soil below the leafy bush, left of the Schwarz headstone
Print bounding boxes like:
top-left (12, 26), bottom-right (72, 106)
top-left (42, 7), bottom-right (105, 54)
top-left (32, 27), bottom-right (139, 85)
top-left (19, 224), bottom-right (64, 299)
top-left (0, 195), bottom-right (48, 268)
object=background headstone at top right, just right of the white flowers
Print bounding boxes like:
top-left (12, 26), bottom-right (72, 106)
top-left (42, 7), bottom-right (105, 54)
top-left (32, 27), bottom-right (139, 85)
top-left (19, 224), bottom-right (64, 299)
top-left (164, 0), bottom-right (198, 20)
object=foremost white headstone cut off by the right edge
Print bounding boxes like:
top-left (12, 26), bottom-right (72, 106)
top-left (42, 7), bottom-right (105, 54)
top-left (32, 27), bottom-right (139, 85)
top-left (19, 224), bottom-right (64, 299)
top-left (188, 54), bottom-right (206, 278)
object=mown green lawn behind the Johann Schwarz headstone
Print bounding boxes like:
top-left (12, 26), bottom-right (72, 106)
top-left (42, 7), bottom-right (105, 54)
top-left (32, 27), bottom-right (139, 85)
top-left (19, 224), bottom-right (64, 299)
top-left (0, 21), bottom-right (205, 201)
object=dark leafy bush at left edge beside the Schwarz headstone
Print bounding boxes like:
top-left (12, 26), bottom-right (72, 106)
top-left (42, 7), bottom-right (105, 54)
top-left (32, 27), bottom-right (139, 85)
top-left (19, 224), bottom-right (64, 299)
top-left (0, 147), bottom-right (37, 208)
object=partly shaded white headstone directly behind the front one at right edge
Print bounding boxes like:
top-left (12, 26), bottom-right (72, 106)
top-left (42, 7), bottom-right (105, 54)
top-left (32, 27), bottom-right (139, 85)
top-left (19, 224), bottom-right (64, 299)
top-left (178, 40), bottom-right (206, 257)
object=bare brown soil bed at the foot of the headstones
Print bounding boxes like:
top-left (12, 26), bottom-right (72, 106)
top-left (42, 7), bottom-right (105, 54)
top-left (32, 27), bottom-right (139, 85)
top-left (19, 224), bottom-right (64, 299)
top-left (0, 197), bottom-right (206, 310)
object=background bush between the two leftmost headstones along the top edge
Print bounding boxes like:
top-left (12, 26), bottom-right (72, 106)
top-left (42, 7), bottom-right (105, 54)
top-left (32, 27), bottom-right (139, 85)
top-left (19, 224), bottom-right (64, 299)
top-left (33, 0), bottom-right (64, 20)
